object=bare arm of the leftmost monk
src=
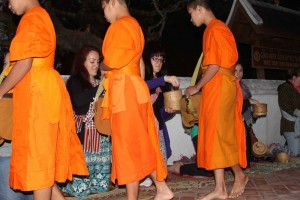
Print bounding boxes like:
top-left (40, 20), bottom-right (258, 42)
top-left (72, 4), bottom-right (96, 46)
top-left (0, 58), bottom-right (33, 99)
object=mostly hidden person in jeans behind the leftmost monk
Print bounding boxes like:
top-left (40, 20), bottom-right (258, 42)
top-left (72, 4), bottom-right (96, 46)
top-left (0, 52), bottom-right (33, 200)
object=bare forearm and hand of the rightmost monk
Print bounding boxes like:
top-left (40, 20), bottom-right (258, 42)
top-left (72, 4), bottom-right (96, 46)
top-left (185, 64), bottom-right (220, 95)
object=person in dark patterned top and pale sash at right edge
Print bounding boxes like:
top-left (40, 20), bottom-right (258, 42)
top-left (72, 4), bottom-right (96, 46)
top-left (277, 67), bottom-right (300, 156)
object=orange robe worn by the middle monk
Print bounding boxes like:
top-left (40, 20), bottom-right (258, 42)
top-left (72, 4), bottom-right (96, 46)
top-left (102, 16), bottom-right (167, 185)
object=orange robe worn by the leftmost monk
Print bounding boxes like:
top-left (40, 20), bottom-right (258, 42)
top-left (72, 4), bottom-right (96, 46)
top-left (10, 7), bottom-right (88, 191)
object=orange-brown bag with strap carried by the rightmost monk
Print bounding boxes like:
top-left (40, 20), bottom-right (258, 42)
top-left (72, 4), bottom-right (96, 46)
top-left (180, 53), bottom-right (203, 128)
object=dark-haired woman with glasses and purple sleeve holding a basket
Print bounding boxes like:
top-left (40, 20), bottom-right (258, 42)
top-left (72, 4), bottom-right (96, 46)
top-left (140, 43), bottom-right (180, 187)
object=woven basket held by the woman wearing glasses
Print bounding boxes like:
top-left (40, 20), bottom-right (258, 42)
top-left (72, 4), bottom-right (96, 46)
top-left (164, 90), bottom-right (182, 111)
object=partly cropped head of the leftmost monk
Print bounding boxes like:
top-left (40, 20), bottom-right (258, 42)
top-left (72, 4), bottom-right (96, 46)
top-left (8, 0), bottom-right (40, 15)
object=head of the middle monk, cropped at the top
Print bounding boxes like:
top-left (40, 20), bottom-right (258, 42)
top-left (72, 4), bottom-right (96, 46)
top-left (101, 0), bottom-right (129, 23)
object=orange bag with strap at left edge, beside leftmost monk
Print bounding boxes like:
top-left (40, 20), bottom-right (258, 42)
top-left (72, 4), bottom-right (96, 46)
top-left (0, 65), bottom-right (13, 145)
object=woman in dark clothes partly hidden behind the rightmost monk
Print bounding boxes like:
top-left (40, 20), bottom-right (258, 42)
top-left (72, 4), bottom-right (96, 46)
top-left (234, 63), bottom-right (259, 167)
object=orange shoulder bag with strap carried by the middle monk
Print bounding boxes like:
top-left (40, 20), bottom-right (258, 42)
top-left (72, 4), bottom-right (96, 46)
top-left (94, 79), bottom-right (111, 135)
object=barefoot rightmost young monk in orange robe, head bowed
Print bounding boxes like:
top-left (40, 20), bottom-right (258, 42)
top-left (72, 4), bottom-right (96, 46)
top-left (185, 0), bottom-right (248, 200)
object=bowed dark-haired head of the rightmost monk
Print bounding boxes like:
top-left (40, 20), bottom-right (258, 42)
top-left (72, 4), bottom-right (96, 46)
top-left (187, 0), bottom-right (215, 27)
